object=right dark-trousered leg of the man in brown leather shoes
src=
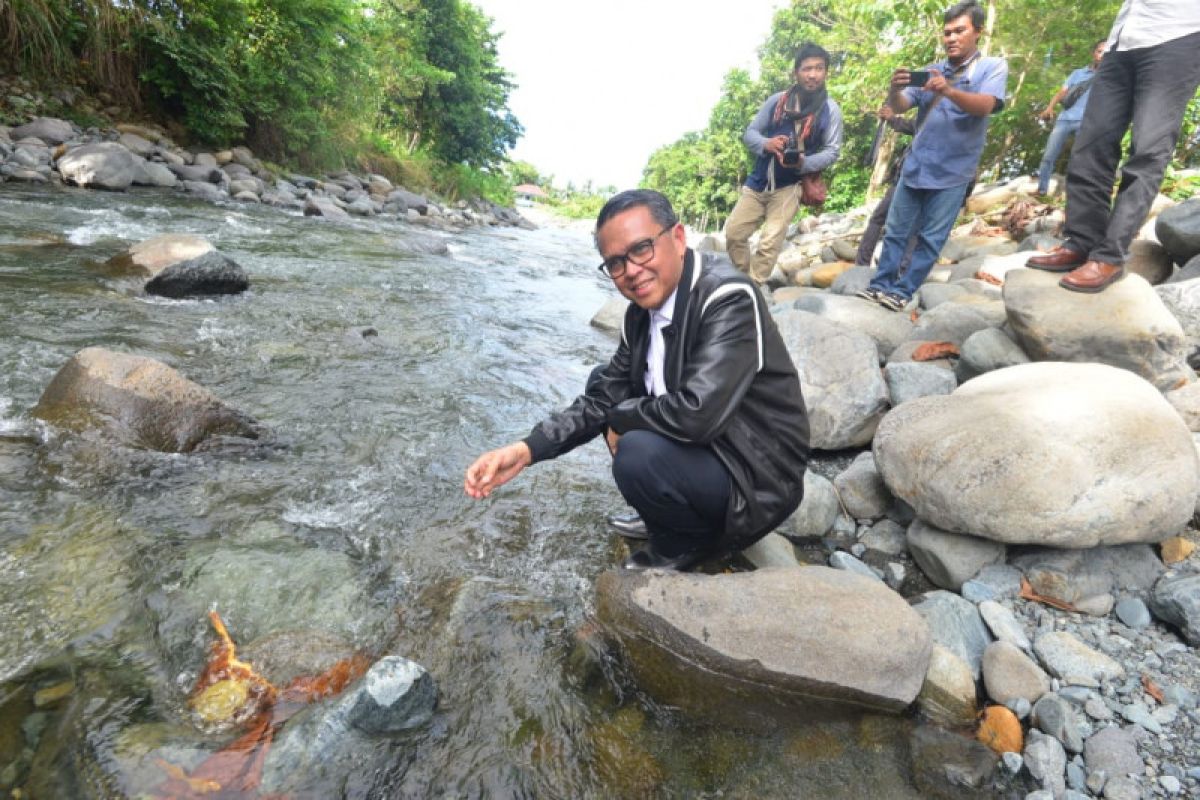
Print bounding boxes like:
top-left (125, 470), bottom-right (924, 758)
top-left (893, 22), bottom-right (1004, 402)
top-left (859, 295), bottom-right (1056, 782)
top-left (1088, 34), bottom-right (1200, 264)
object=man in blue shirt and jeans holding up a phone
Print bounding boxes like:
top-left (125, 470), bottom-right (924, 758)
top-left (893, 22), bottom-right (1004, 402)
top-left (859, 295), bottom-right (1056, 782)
top-left (858, 0), bottom-right (1008, 311)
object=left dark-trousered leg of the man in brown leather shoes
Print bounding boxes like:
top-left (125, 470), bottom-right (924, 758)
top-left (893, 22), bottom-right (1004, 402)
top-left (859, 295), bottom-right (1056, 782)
top-left (1063, 50), bottom-right (1136, 255)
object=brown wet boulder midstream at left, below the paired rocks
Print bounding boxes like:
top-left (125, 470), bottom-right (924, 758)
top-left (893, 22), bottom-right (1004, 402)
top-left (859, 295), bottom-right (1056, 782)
top-left (34, 348), bottom-right (262, 452)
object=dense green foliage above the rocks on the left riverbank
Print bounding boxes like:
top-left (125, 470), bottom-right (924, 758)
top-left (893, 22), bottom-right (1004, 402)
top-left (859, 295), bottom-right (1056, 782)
top-left (0, 0), bottom-right (521, 199)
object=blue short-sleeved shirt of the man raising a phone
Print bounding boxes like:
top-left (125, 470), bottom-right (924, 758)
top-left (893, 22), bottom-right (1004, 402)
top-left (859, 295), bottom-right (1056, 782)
top-left (900, 55), bottom-right (1008, 190)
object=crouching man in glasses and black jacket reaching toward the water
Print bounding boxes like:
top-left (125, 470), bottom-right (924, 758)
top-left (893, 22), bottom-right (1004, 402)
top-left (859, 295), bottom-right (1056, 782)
top-left (463, 190), bottom-right (809, 570)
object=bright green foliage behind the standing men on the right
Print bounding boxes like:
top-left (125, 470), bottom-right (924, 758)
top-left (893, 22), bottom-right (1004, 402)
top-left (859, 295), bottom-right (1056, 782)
top-left (642, 0), bottom-right (1200, 229)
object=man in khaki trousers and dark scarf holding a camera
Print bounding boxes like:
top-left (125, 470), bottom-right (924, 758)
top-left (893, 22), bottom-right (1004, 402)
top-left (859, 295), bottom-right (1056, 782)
top-left (725, 42), bottom-right (841, 285)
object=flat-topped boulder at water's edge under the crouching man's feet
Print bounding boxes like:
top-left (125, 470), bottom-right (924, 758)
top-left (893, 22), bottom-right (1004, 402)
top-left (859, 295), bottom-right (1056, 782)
top-left (596, 566), bottom-right (931, 716)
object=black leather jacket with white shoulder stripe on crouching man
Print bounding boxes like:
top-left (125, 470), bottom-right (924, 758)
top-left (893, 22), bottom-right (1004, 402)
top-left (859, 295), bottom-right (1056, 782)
top-left (524, 249), bottom-right (809, 548)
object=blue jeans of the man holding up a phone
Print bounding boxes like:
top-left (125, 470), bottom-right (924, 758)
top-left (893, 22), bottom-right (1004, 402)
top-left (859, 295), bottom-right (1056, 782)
top-left (871, 178), bottom-right (970, 300)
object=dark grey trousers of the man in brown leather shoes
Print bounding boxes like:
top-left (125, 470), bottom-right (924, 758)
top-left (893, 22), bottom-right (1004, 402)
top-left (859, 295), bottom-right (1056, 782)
top-left (1064, 32), bottom-right (1200, 264)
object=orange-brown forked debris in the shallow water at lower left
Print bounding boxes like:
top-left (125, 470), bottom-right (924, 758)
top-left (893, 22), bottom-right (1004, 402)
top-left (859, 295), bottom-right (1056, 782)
top-left (154, 612), bottom-right (371, 800)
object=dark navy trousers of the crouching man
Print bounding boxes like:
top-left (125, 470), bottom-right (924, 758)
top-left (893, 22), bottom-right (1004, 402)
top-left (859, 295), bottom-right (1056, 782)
top-left (612, 431), bottom-right (732, 557)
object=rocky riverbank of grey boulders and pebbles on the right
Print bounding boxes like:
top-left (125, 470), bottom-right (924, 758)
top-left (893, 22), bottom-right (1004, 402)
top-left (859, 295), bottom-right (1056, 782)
top-left (593, 179), bottom-right (1200, 800)
